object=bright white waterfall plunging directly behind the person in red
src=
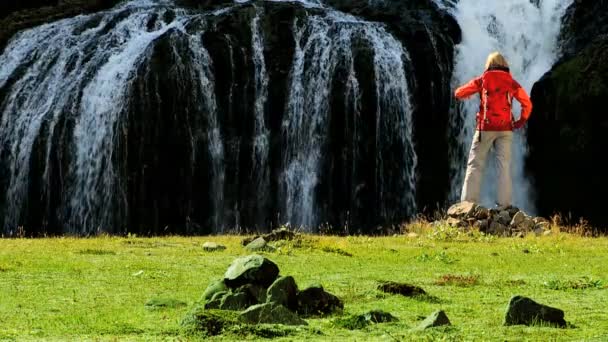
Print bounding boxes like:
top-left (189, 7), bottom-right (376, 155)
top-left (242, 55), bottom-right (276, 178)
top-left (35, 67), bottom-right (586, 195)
top-left (444, 0), bottom-right (572, 214)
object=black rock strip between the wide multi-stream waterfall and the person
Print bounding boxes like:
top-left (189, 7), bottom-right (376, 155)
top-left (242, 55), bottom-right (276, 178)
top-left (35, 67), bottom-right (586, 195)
top-left (325, 0), bottom-right (461, 211)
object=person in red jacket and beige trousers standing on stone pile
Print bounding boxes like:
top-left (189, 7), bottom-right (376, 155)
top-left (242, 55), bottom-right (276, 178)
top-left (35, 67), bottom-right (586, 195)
top-left (455, 52), bottom-right (532, 206)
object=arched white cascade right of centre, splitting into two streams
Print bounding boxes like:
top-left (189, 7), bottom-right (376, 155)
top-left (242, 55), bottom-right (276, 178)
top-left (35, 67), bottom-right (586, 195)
top-left (282, 11), bottom-right (416, 228)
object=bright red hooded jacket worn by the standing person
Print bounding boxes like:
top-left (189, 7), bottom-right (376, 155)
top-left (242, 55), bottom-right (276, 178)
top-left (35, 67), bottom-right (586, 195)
top-left (455, 68), bottom-right (532, 131)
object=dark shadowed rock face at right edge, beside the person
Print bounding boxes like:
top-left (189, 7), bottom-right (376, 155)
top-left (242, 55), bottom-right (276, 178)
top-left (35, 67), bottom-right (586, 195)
top-left (526, 1), bottom-right (608, 230)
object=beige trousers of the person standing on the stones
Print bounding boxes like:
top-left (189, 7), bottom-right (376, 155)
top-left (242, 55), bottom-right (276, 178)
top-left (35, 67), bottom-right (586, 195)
top-left (461, 131), bottom-right (513, 206)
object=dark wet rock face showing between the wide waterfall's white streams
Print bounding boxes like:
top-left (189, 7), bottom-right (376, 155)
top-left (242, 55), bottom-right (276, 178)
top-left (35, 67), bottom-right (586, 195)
top-left (0, 0), bottom-right (459, 235)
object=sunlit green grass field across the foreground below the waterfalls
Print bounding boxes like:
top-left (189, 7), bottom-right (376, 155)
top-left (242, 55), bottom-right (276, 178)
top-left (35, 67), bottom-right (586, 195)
top-left (0, 229), bottom-right (608, 341)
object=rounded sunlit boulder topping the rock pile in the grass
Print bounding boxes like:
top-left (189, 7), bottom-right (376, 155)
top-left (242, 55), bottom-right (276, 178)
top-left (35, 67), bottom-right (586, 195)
top-left (224, 254), bottom-right (279, 289)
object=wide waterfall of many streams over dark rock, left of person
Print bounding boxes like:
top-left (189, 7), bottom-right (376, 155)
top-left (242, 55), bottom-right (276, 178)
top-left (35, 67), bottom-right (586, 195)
top-left (0, 0), bottom-right (417, 236)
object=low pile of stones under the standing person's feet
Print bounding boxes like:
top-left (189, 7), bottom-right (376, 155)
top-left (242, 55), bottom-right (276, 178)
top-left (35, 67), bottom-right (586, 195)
top-left (446, 202), bottom-right (551, 237)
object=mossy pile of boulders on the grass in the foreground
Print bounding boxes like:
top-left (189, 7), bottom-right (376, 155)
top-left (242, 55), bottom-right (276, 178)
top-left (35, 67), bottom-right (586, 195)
top-left (202, 254), bottom-right (344, 325)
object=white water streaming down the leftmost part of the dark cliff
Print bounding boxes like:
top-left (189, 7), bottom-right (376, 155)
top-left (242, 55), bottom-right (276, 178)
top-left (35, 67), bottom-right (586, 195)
top-left (0, 0), bottom-right (223, 233)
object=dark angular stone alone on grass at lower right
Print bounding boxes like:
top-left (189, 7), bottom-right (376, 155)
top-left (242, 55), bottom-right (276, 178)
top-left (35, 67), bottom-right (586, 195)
top-left (504, 296), bottom-right (566, 327)
